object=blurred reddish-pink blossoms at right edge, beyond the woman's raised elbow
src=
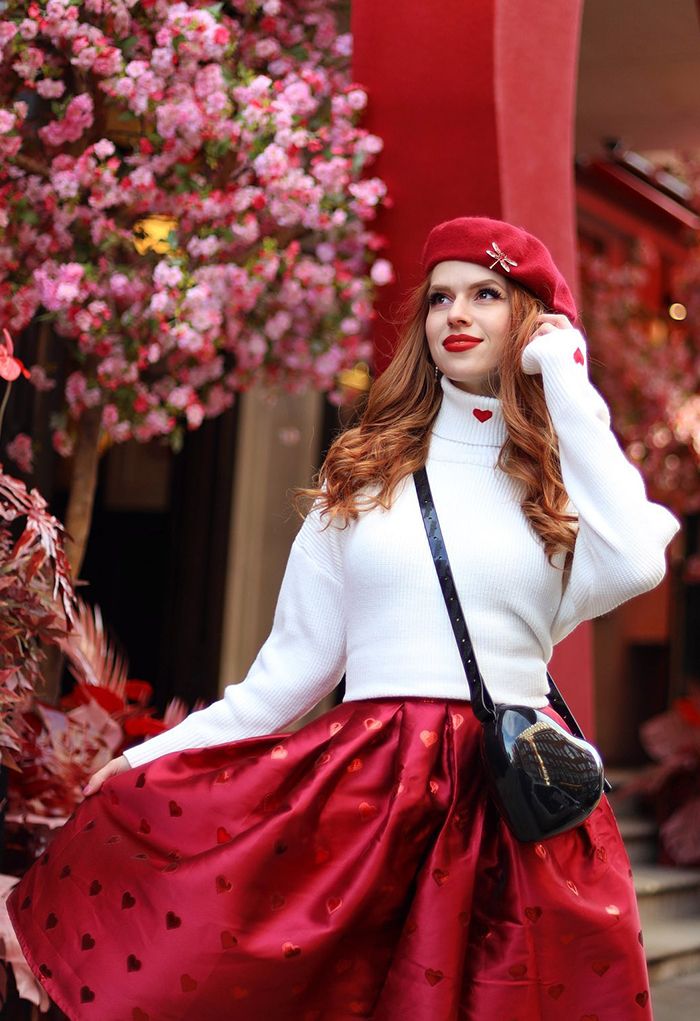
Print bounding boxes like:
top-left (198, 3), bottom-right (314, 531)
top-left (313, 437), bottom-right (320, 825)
top-left (582, 236), bottom-right (700, 515)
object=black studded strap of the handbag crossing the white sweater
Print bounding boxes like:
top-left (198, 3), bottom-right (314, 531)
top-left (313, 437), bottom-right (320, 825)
top-left (413, 467), bottom-right (610, 767)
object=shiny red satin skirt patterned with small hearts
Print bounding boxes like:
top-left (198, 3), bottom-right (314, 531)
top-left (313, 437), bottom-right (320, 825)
top-left (9, 698), bottom-right (651, 1021)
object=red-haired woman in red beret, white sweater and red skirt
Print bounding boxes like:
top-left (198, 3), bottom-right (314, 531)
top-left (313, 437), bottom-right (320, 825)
top-left (10, 211), bottom-right (678, 1021)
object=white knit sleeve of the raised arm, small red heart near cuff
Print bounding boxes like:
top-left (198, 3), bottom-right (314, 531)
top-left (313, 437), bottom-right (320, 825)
top-left (522, 329), bottom-right (680, 641)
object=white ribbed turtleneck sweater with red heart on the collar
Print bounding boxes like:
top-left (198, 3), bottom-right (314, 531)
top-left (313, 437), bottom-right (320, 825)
top-left (127, 330), bottom-right (679, 766)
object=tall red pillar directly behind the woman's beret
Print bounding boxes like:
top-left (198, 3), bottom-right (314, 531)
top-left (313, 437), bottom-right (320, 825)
top-left (352, 0), bottom-right (593, 732)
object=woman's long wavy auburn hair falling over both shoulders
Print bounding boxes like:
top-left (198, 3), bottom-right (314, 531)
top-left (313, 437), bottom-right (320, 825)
top-left (297, 278), bottom-right (576, 561)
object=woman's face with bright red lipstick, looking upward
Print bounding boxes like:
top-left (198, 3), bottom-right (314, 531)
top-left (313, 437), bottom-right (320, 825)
top-left (426, 259), bottom-right (510, 394)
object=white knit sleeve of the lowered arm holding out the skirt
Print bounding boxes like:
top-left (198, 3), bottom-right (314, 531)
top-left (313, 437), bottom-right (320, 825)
top-left (126, 509), bottom-right (346, 766)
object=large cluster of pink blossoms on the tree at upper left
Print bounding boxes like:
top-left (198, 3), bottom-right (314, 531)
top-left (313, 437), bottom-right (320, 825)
top-left (0, 0), bottom-right (392, 453)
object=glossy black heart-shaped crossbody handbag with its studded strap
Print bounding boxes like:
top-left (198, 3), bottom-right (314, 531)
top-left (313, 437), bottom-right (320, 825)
top-left (413, 468), bottom-right (610, 841)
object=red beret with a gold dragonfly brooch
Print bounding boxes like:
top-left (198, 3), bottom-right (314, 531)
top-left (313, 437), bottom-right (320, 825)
top-left (422, 216), bottom-right (578, 322)
